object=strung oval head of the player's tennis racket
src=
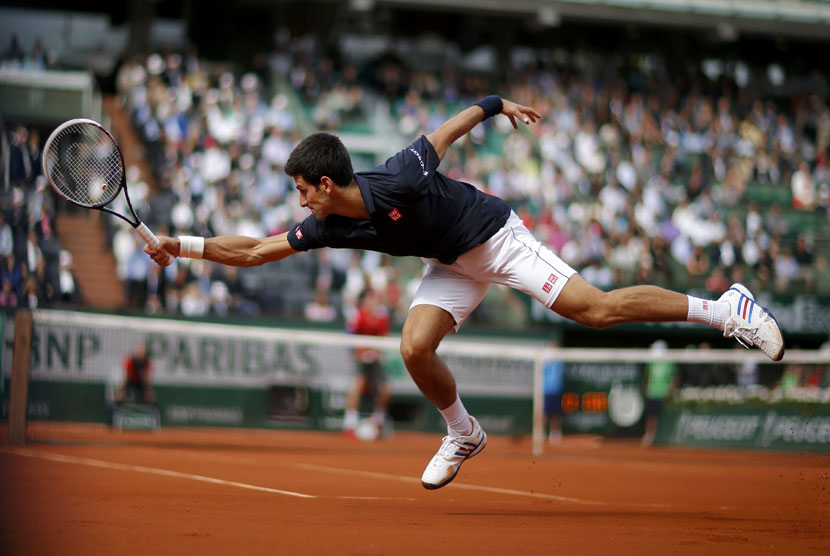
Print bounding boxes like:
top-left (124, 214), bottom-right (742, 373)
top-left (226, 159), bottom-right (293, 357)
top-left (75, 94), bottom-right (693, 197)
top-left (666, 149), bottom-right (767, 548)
top-left (46, 123), bottom-right (124, 206)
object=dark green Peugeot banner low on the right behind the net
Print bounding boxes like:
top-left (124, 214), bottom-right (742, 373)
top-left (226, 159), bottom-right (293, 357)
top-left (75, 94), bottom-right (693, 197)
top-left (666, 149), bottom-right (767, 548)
top-left (655, 404), bottom-right (830, 454)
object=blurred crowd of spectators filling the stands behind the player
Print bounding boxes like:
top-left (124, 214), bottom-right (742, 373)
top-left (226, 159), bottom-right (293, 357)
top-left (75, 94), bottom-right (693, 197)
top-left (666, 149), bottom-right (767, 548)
top-left (0, 34), bottom-right (830, 326)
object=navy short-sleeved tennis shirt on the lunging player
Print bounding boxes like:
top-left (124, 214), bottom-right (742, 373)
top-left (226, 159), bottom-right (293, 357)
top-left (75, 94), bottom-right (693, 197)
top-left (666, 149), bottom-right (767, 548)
top-left (288, 135), bottom-right (510, 264)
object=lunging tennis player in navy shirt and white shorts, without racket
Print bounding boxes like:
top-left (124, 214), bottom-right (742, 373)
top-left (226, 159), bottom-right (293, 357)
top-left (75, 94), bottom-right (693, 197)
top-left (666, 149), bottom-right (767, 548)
top-left (145, 95), bottom-right (784, 489)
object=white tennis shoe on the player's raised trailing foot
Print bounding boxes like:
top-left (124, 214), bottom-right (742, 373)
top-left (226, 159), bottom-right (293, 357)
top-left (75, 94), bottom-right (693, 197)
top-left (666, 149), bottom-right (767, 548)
top-left (718, 283), bottom-right (784, 361)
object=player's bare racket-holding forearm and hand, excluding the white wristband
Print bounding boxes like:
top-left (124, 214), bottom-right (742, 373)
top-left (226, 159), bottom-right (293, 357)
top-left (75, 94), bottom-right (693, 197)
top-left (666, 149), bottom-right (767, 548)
top-left (144, 232), bottom-right (297, 266)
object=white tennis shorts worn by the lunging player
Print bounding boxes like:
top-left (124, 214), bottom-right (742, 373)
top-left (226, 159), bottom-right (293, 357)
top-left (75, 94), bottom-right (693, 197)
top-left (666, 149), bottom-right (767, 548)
top-left (410, 212), bottom-right (576, 331)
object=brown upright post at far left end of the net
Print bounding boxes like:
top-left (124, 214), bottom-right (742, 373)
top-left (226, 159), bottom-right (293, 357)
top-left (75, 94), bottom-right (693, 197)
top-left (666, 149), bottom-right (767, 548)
top-left (9, 311), bottom-right (32, 444)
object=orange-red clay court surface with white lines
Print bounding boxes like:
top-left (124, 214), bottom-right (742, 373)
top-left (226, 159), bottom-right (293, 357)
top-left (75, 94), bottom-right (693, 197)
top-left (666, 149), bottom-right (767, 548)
top-left (0, 429), bottom-right (830, 555)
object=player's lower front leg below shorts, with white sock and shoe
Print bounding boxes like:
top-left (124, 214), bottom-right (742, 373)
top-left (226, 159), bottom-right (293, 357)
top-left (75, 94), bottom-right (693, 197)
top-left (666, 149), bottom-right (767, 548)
top-left (401, 305), bottom-right (487, 490)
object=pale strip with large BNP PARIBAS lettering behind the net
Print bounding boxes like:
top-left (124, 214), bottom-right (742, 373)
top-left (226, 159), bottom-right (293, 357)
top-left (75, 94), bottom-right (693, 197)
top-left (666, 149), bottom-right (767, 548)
top-left (3, 311), bottom-right (533, 398)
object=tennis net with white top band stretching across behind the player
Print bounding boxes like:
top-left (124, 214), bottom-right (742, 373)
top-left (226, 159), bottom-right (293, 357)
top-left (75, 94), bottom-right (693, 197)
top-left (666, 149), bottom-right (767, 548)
top-left (2, 310), bottom-right (830, 454)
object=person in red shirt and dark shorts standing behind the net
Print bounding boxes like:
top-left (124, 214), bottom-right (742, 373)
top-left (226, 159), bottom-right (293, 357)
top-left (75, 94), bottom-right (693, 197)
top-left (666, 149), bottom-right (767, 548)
top-left (343, 290), bottom-right (390, 438)
